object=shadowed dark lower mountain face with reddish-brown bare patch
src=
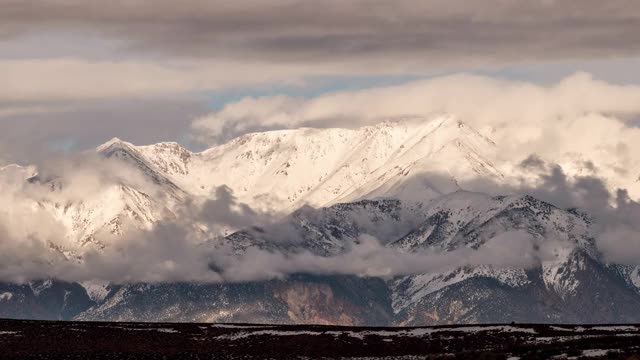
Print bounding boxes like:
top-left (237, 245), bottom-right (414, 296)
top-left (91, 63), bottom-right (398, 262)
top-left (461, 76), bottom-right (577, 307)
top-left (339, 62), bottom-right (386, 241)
top-left (76, 275), bottom-right (393, 326)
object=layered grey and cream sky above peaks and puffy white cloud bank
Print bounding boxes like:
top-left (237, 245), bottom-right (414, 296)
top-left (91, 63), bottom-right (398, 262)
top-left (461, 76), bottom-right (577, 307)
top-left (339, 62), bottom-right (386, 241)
top-left (0, 0), bottom-right (640, 163)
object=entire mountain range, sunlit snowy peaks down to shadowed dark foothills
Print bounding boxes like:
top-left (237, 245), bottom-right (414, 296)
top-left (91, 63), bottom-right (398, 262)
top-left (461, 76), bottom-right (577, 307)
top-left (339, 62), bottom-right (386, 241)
top-left (0, 118), bottom-right (640, 325)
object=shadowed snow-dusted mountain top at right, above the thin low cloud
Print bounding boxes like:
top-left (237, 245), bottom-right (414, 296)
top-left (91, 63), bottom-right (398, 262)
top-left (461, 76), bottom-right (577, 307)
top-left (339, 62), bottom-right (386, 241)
top-left (393, 191), bottom-right (595, 251)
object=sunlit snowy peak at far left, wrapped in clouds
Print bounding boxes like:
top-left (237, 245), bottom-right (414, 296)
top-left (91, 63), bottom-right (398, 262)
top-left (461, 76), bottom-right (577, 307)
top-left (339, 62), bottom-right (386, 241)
top-left (5, 139), bottom-right (188, 252)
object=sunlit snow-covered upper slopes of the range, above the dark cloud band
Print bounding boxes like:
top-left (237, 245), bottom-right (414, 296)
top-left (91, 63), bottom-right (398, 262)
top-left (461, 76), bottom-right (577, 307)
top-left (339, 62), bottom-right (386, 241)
top-left (28, 117), bottom-right (500, 247)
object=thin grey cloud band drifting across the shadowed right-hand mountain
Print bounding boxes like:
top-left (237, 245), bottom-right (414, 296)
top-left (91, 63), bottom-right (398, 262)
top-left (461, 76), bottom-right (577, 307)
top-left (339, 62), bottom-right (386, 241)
top-left (214, 231), bottom-right (571, 281)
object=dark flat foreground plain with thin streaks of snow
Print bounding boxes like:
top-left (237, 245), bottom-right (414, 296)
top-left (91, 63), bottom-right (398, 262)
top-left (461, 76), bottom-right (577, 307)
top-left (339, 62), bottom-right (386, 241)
top-left (0, 320), bottom-right (640, 359)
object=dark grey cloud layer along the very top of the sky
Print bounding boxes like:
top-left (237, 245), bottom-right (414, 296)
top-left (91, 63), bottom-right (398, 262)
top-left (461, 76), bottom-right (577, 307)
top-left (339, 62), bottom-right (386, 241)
top-left (0, 0), bottom-right (640, 67)
